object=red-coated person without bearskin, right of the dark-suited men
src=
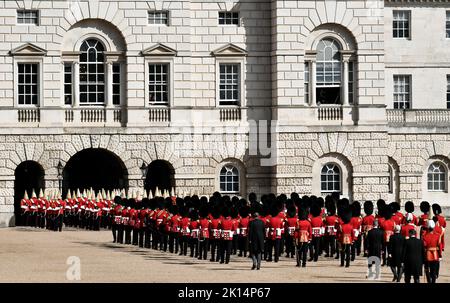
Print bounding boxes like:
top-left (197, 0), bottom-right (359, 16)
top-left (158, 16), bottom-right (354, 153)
top-left (422, 220), bottom-right (442, 283)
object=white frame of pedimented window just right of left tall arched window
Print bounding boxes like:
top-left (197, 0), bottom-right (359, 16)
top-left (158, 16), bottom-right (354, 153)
top-left (144, 56), bottom-right (174, 108)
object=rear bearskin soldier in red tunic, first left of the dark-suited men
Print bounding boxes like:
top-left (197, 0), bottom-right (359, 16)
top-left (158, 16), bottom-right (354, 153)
top-left (337, 206), bottom-right (356, 267)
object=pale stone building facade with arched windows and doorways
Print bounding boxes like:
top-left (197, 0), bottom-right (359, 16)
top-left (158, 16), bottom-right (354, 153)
top-left (0, 0), bottom-right (450, 226)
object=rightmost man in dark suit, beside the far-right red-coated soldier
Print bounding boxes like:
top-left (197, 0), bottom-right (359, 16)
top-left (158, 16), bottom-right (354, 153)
top-left (403, 229), bottom-right (425, 283)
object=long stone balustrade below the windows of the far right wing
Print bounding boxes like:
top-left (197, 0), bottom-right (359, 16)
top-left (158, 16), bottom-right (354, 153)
top-left (386, 109), bottom-right (450, 126)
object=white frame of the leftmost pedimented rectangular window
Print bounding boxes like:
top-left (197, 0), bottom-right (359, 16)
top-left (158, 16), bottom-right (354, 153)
top-left (14, 56), bottom-right (44, 108)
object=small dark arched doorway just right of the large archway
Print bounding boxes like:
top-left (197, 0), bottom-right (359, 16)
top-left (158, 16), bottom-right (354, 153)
top-left (144, 160), bottom-right (175, 192)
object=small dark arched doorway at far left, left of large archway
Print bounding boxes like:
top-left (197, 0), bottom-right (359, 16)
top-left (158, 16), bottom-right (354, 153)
top-left (14, 161), bottom-right (45, 225)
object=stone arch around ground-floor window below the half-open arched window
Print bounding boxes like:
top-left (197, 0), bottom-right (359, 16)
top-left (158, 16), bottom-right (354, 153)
top-left (312, 153), bottom-right (353, 200)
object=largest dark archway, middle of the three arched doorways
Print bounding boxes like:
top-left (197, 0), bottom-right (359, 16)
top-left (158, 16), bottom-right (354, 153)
top-left (63, 148), bottom-right (128, 197)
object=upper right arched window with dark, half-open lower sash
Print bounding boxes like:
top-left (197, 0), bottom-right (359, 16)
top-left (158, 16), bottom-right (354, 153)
top-left (316, 38), bottom-right (342, 104)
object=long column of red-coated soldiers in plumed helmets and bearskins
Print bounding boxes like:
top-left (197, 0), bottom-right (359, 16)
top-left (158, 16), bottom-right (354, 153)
top-left (21, 188), bottom-right (446, 283)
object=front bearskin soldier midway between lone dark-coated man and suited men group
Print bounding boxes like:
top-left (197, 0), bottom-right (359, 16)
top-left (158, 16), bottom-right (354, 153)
top-left (294, 207), bottom-right (312, 267)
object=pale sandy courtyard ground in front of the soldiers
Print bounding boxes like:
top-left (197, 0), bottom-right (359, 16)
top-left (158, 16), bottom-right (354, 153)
top-left (0, 227), bottom-right (450, 283)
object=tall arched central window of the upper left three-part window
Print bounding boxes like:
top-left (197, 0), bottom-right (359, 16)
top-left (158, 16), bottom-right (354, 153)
top-left (80, 39), bottom-right (105, 105)
